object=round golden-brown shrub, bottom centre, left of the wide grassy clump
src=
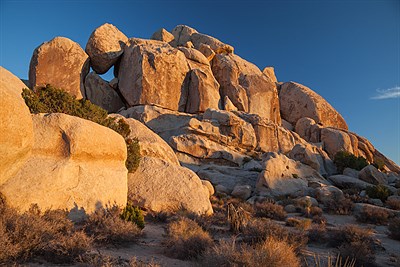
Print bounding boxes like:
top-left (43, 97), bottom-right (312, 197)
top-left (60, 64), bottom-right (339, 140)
top-left (165, 217), bottom-right (213, 260)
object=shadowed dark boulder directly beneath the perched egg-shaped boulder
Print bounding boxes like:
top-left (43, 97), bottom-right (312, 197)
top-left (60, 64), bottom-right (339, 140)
top-left (85, 72), bottom-right (125, 112)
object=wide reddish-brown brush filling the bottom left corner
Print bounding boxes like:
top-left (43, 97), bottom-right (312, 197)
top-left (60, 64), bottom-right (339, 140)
top-left (0, 203), bottom-right (92, 265)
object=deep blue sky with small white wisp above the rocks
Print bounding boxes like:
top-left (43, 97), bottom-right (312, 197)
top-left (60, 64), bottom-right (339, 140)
top-left (0, 0), bottom-right (400, 164)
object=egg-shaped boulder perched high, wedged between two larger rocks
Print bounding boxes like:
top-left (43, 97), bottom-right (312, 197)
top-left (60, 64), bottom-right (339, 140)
top-left (85, 23), bottom-right (128, 74)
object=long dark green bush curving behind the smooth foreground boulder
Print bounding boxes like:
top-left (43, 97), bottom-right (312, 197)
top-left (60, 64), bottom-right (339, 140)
top-left (22, 84), bottom-right (140, 173)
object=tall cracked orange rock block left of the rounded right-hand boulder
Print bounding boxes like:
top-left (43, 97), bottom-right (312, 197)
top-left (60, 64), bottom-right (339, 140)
top-left (212, 54), bottom-right (281, 125)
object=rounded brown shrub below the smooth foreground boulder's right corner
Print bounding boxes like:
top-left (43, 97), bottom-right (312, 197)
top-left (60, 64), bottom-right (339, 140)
top-left (84, 206), bottom-right (142, 245)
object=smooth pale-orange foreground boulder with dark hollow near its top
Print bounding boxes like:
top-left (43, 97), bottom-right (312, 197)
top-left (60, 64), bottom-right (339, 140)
top-left (0, 113), bottom-right (128, 213)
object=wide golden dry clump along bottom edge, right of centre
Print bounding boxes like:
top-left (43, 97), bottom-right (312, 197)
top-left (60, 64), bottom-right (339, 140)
top-left (202, 238), bottom-right (300, 267)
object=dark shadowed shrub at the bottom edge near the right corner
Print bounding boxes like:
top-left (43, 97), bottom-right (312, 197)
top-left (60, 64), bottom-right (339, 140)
top-left (329, 225), bottom-right (375, 266)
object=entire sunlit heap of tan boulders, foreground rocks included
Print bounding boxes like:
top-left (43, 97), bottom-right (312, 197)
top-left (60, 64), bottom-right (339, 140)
top-left (0, 24), bottom-right (400, 219)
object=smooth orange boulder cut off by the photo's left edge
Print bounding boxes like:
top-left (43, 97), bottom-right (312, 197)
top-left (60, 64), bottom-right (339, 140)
top-left (0, 66), bottom-right (33, 186)
